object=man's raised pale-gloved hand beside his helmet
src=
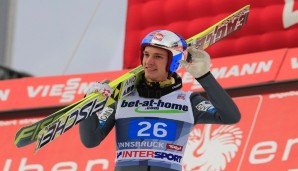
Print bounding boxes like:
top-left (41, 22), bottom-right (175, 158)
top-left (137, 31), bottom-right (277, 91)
top-left (179, 47), bottom-right (210, 78)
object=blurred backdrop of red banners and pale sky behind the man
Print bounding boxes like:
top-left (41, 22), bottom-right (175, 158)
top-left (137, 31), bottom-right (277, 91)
top-left (0, 0), bottom-right (298, 171)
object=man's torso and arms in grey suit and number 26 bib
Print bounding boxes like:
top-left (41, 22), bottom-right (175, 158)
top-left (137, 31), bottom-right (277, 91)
top-left (80, 72), bottom-right (240, 171)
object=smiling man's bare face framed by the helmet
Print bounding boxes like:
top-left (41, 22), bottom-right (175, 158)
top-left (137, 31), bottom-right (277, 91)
top-left (143, 46), bottom-right (168, 82)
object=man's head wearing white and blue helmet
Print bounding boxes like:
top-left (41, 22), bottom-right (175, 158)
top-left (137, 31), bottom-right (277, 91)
top-left (141, 30), bottom-right (187, 81)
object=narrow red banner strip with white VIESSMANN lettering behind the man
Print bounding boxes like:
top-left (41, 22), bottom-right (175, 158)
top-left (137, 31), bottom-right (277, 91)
top-left (0, 48), bottom-right (298, 112)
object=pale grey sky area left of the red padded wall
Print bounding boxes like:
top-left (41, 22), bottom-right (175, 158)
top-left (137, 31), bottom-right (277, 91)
top-left (0, 0), bottom-right (127, 76)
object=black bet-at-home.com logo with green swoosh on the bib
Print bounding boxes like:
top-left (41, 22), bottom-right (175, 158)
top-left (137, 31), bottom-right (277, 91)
top-left (121, 99), bottom-right (188, 114)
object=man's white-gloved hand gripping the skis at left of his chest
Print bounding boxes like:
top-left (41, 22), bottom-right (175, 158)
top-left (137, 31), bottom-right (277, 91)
top-left (86, 80), bottom-right (113, 97)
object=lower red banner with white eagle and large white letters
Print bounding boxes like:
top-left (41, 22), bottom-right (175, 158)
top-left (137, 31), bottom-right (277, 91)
top-left (0, 89), bottom-right (298, 171)
